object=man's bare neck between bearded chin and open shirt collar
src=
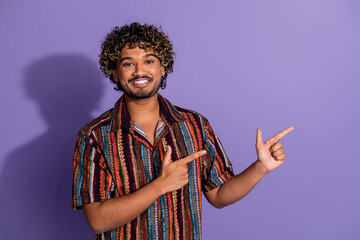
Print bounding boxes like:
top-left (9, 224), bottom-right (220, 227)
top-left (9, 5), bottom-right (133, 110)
top-left (124, 93), bottom-right (160, 124)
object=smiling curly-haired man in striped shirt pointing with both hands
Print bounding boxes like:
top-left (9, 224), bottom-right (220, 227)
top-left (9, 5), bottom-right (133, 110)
top-left (73, 23), bottom-right (293, 239)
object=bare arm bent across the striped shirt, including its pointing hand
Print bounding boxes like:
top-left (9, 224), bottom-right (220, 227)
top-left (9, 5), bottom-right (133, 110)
top-left (83, 146), bottom-right (206, 234)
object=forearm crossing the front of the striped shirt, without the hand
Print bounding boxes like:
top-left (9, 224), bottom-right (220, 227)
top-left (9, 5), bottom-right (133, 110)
top-left (84, 179), bottom-right (164, 234)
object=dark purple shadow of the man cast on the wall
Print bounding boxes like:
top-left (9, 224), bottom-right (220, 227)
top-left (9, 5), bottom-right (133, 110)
top-left (0, 55), bottom-right (104, 240)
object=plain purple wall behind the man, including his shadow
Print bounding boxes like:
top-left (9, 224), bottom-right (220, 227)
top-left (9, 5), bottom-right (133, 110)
top-left (0, 0), bottom-right (360, 240)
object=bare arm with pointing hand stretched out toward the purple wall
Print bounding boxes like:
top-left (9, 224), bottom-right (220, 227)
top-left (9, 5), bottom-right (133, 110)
top-left (204, 127), bottom-right (294, 208)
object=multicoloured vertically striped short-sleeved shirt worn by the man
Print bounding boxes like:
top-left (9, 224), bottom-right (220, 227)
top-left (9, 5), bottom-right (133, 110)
top-left (72, 94), bottom-right (233, 240)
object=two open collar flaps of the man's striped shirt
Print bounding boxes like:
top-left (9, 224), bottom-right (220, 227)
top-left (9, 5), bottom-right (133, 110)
top-left (109, 94), bottom-right (185, 132)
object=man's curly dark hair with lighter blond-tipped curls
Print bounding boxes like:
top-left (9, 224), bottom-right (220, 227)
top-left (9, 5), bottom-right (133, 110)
top-left (99, 22), bottom-right (175, 90)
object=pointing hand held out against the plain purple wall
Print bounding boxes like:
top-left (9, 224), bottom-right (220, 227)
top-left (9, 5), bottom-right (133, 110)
top-left (256, 127), bottom-right (294, 173)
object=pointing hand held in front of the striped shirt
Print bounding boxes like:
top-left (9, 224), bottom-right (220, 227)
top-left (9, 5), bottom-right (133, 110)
top-left (159, 145), bottom-right (206, 193)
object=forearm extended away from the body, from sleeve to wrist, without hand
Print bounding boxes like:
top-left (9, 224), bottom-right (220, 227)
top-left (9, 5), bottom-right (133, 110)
top-left (215, 161), bottom-right (266, 208)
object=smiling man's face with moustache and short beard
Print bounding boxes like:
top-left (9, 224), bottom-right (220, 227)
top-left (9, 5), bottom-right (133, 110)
top-left (113, 46), bottom-right (165, 99)
